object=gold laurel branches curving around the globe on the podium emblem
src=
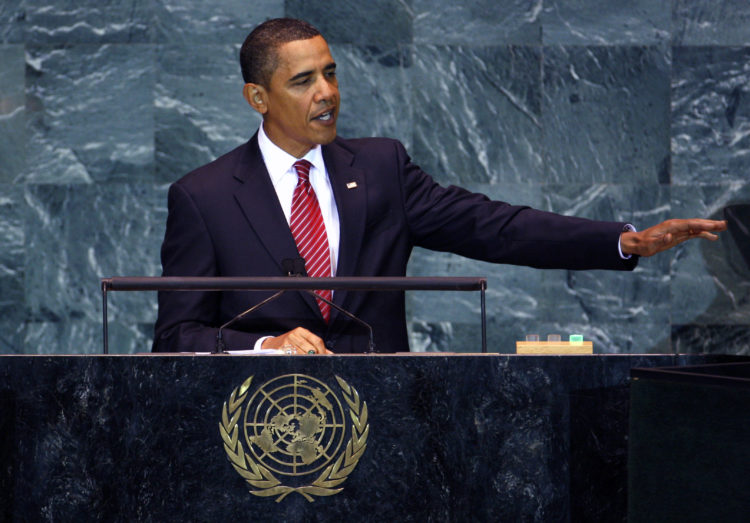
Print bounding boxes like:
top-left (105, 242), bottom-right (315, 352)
top-left (219, 376), bottom-right (370, 503)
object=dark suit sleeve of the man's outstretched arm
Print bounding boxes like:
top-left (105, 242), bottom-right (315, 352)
top-left (396, 143), bottom-right (638, 270)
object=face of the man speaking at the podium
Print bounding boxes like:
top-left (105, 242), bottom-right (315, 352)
top-left (259, 36), bottom-right (339, 158)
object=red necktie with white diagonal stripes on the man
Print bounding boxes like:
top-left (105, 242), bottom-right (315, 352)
top-left (289, 160), bottom-right (333, 323)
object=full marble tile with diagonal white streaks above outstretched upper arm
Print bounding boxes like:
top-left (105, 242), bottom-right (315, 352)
top-left (408, 46), bottom-right (543, 184)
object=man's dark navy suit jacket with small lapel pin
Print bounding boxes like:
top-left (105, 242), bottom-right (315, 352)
top-left (153, 135), bottom-right (637, 353)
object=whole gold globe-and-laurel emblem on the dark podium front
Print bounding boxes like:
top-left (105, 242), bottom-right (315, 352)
top-left (219, 374), bottom-right (370, 503)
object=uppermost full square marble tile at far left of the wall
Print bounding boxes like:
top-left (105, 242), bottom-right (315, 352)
top-left (23, 44), bottom-right (155, 184)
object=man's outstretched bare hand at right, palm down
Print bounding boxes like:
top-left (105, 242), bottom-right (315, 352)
top-left (620, 218), bottom-right (727, 256)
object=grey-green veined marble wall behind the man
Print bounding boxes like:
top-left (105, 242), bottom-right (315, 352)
top-left (0, 0), bottom-right (750, 353)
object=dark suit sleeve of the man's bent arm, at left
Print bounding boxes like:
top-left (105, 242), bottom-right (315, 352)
top-left (152, 183), bottom-right (266, 352)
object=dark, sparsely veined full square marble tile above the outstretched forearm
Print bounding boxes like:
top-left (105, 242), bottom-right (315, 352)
top-left (543, 46), bottom-right (669, 184)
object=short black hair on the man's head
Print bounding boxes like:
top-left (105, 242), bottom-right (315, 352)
top-left (240, 18), bottom-right (320, 88)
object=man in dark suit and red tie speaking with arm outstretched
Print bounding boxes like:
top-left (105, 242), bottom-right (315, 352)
top-left (153, 19), bottom-right (726, 354)
